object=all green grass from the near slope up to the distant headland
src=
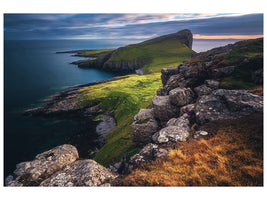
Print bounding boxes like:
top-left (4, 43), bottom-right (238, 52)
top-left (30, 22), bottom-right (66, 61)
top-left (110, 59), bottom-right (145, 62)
top-left (70, 30), bottom-right (194, 166)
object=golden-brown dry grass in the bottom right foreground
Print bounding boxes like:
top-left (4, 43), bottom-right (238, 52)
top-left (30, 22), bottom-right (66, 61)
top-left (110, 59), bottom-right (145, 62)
top-left (122, 114), bottom-right (263, 186)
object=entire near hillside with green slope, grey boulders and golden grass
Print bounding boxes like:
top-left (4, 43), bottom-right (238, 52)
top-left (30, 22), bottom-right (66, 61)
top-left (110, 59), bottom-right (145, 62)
top-left (6, 36), bottom-right (263, 186)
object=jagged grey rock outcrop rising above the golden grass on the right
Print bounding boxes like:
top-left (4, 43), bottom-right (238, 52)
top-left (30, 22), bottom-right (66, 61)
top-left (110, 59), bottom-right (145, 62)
top-left (130, 39), bottom-right (263, 169)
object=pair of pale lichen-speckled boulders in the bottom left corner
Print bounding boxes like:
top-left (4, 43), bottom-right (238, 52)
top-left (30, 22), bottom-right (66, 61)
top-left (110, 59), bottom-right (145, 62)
top-left (6, 144), bottom-right (117, 186)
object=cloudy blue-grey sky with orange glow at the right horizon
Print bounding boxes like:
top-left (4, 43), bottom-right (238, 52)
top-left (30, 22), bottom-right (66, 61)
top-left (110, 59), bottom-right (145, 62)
top-left (4, 13), bottom-right (263, 40)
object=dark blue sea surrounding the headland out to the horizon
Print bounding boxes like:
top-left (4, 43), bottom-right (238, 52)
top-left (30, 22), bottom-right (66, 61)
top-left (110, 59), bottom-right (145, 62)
top-left (3, 39), bottom-right (242, 177)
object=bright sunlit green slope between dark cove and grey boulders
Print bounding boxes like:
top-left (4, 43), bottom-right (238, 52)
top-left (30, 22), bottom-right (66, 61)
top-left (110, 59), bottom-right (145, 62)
top-left (76, 73), bottom-right (161, 165)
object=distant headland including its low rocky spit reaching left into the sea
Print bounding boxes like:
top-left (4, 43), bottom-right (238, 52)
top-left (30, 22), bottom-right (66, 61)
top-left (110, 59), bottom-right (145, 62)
top-left (65, 29), bottom-right (193, 73)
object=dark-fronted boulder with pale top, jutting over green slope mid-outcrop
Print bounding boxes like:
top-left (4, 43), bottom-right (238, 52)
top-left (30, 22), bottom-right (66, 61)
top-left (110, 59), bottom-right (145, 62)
top-left (152, 96), bottom-right (179, 125)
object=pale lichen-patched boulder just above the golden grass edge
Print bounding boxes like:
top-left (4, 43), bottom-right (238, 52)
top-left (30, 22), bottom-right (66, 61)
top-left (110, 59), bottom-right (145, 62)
top-left (157, 126), bottom-right (189, 143)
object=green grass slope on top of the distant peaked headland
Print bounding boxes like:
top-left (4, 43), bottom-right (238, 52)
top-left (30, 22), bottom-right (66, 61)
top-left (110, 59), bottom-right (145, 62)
top-left (108, 31), bottom-right (195, 74)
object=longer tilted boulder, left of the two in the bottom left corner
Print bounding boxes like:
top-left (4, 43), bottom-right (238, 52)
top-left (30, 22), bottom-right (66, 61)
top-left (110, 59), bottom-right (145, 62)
top-left (6, 144), bottom-right (79, 186)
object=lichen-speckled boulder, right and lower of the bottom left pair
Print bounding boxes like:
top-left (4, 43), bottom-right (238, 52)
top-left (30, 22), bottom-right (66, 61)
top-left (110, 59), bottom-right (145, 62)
top-left (40, 159), bottom-right (117, 187)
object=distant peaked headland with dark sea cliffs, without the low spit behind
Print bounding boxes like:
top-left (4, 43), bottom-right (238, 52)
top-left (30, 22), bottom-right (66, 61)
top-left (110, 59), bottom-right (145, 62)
top-left (76, 29), bottom-right (194, 73)
